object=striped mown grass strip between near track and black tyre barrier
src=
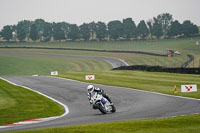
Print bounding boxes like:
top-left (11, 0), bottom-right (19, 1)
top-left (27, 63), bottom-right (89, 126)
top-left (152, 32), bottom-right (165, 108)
top-left (60, 71), bottom-right (200, 99)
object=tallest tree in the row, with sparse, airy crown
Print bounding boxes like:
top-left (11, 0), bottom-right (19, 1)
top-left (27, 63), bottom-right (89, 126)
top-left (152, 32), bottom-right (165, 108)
top-left (157, 13), bottom-right (173, 38)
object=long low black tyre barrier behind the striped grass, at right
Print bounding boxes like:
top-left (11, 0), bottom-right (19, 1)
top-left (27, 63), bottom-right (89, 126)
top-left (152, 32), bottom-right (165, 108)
top-left (113, 65), bottom-right (200, 74)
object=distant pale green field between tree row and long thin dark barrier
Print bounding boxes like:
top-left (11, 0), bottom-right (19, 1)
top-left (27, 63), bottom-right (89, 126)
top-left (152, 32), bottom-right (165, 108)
top-left (0, 38), bottom-right (200, 53)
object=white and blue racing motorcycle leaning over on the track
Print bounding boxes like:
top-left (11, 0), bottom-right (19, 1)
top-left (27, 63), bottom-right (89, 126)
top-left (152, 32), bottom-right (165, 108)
top-left (91, 93), bottom-right (116, 114)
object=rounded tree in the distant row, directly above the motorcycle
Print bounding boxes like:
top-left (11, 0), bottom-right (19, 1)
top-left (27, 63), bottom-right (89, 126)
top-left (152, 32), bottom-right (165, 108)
top-left (96, 22), bottom-right (107, 41)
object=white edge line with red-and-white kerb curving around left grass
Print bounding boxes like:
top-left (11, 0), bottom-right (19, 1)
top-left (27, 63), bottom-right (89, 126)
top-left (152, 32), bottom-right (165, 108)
top-left (0, 77), bottom-right (69, 128)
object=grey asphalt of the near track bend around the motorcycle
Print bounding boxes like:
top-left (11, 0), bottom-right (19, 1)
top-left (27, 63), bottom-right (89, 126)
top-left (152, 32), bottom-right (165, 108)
top-left (0, 76), bottom-right (200, 131)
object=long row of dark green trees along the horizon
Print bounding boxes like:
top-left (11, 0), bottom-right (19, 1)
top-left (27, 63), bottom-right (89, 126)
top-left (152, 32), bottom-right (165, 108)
top-left (0, 13), bottom-right (199, 42)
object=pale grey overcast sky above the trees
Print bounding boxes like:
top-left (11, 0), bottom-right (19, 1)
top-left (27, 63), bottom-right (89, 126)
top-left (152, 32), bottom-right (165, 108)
top-left (0, 0), bottom-right (200, 29)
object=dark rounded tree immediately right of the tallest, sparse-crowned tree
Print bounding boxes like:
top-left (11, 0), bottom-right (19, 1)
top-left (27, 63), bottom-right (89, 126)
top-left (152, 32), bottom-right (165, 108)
top-left (167, 20), bottom-right (182, 37)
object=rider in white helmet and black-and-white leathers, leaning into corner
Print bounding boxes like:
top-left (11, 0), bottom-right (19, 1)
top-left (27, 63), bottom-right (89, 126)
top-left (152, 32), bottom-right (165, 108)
top-left (87, 85), bottom-right (113, 104)
